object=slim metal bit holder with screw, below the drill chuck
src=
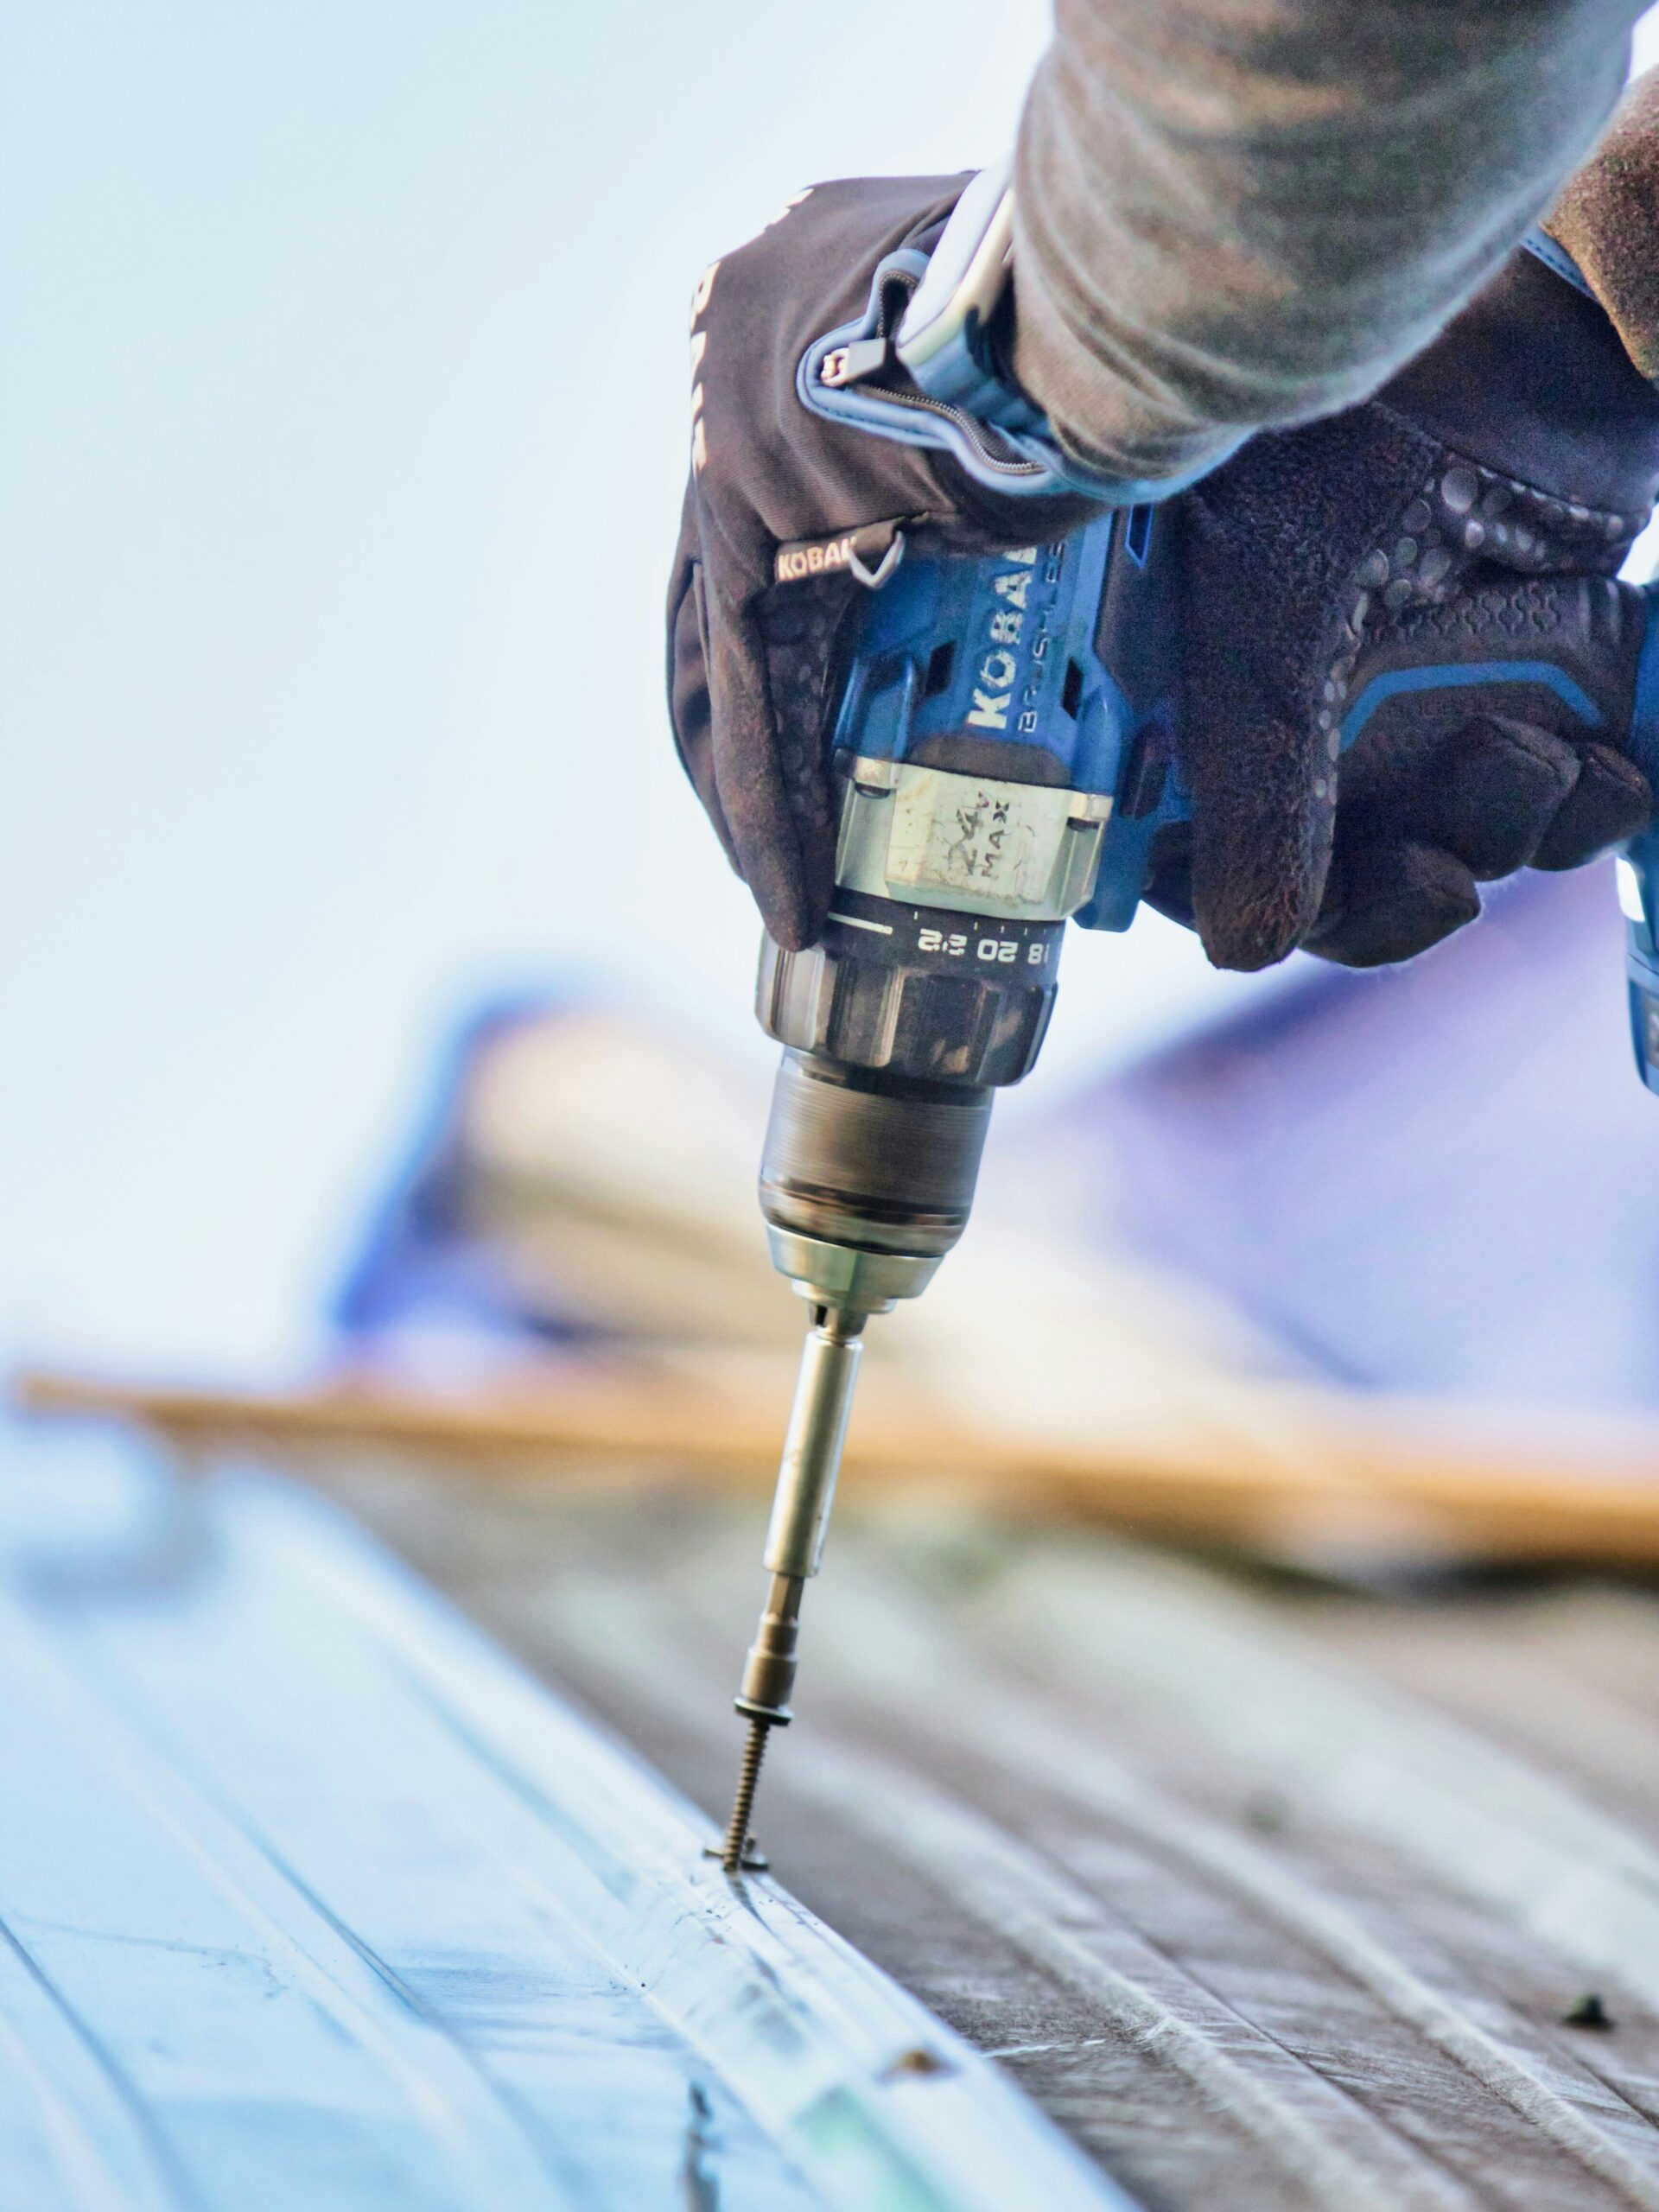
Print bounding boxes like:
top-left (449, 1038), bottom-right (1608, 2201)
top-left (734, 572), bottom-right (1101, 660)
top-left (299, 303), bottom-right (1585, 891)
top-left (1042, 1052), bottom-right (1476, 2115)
top-left (721, 1305), bottom-right (868, 1873)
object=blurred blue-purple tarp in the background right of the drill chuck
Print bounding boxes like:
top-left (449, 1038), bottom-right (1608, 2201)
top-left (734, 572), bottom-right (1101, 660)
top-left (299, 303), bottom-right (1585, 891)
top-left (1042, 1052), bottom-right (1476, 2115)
top-left (1058, 865), bottom-right (1659, 1405)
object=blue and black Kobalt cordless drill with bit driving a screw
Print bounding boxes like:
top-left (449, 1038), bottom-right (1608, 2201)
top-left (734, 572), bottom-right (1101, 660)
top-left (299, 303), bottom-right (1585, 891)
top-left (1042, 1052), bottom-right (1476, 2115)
top-left (721, 480), bottom-right (1659, 1872)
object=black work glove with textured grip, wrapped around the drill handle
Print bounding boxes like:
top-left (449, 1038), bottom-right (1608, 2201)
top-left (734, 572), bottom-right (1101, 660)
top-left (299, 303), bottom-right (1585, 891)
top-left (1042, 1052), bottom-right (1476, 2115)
top-left (1150, 250), bottom-right (1659, 969)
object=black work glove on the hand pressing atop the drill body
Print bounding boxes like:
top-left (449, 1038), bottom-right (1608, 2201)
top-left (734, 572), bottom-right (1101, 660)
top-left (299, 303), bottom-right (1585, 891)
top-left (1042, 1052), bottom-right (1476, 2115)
top-left (668, 177), bottom-right (1095, 949)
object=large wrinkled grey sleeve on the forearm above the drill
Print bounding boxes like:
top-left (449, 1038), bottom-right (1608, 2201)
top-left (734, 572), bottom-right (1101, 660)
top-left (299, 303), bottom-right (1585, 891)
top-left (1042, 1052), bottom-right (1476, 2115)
top-left (1015, 0), bottom-right (1643, 480)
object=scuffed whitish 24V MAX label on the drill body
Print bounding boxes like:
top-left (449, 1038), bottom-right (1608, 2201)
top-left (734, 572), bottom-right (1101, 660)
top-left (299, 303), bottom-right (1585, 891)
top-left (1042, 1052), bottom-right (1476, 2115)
top-left (887, 766), bottom-right (1073, 909)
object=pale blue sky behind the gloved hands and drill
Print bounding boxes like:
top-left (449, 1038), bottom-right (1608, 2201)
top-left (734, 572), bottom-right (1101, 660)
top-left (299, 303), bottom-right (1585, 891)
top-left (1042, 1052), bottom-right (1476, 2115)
top-left (0, 0), bottom-right (1654, 1371)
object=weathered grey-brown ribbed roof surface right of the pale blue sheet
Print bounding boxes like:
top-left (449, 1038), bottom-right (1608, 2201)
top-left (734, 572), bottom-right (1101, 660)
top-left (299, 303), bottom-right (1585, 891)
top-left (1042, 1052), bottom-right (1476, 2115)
top-left (321, 1469), bottom-right (1659, 2212)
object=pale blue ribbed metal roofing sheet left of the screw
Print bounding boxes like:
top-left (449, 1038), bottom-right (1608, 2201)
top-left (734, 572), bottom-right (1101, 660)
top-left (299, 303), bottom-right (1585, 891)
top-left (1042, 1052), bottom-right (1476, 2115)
top-left (0, 1462), bottom-right (1123, 2212)
